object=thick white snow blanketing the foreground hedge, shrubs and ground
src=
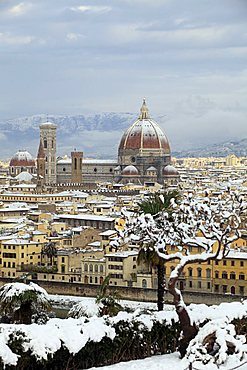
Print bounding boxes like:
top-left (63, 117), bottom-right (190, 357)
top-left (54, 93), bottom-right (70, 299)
top-left (0, 295), bottom-right (247, 370)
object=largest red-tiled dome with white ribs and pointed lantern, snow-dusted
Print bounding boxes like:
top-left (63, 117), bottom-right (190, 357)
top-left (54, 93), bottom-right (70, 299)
top-left (119, 99), bottom-right (170, 154)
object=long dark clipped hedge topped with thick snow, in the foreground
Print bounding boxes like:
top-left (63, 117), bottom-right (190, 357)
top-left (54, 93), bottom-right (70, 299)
top-left (0, 310), bottom-right (180, 370)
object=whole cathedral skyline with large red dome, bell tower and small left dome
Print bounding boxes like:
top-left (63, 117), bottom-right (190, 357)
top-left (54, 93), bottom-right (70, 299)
top-left (9, 99), bottom-right (179, 190)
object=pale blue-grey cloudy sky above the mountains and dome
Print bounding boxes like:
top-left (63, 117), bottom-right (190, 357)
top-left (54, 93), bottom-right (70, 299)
top-left (0, 0), bottom-right (247, 147)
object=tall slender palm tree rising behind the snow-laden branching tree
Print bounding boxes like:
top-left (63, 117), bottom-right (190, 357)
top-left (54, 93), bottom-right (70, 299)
top-left (137, 190), bottom-right (180, 311)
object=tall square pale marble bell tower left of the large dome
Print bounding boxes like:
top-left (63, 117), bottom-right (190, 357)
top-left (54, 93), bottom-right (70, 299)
top-left (39, 122), bottom-right (57, 184)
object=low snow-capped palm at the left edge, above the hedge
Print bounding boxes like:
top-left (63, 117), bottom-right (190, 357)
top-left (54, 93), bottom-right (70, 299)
top-left (0, 282), bottom-right (51, 324)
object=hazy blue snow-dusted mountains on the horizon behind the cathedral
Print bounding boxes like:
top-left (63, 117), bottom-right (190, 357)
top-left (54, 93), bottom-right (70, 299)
top-left (0, 112), bottom-right (247, 159)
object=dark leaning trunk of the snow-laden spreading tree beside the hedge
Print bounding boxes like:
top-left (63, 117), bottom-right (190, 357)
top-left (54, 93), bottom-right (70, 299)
top-left (168, 277), bottom-right (198, 357)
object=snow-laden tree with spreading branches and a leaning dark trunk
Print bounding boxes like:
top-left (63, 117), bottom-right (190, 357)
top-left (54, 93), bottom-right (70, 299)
top-left (113, 192), bottom-right (246, 356)
